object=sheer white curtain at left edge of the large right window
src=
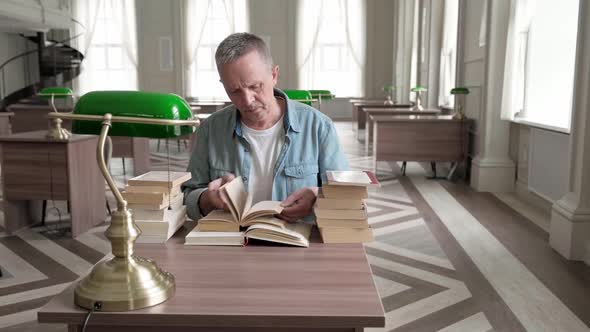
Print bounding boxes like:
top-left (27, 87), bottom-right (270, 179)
top-left (501, 0), bottom-right (536, 120)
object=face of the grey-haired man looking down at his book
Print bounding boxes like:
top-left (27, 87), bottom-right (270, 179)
top-left (218, 50), bottom-right (279, 121)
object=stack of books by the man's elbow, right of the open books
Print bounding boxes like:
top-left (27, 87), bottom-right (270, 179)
top-left (314, 171), bottom-right (379, 243)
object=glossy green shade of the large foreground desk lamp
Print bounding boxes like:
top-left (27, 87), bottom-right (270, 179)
top-left (72, 91), bottom-right (194, 138)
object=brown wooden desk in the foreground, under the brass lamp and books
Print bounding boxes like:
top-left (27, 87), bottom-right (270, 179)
top-left (38, 243), bottom-right (385, 332)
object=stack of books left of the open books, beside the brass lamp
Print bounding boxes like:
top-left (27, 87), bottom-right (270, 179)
top-left (121, 171), bottom-right (191, 243)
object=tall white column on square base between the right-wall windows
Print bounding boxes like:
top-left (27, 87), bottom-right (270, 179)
top-left (472, 1), bottom-right (516, 192)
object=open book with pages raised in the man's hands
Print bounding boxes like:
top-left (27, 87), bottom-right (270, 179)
top-left (199, 177), bottom-right (283, 232)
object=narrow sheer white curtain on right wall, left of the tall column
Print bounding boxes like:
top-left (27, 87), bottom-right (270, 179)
top-left (438, 0), bottom-right (459, 107)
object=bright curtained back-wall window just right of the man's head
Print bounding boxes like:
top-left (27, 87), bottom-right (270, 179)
top-left (297, 0), bottom-right (365, 97)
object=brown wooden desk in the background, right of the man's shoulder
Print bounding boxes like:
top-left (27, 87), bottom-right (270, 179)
top-left (372, 115), bottom-right (472, 175)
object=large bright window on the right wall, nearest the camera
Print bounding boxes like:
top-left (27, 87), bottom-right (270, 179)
top-left (502, 0), bottom-right (579, 132)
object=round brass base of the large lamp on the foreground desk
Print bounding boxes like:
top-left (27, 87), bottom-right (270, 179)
top-left (74, 256), bottom-right (175, 311)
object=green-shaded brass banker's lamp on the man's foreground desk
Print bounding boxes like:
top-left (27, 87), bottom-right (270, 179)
top-left (48, 91), bottom-right (199, 311)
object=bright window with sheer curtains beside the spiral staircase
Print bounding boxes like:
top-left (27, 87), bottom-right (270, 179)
top-left (74, 0), bottom-right (137, 95)
